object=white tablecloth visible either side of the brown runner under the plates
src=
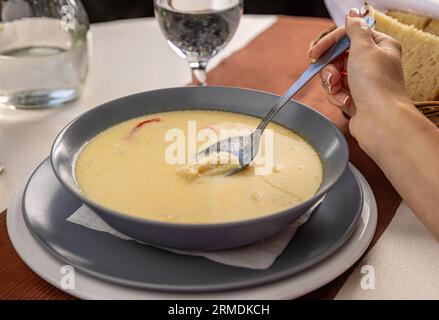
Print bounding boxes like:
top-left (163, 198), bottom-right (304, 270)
top-left (0, 15), bottom-right (439, 299)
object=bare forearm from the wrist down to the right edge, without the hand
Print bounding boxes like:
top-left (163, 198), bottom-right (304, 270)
top-left (368, 101), bottom-right (439, 240)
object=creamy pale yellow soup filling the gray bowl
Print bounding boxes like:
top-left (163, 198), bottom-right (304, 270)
top-left (75, 111), bottom-right (322, 223)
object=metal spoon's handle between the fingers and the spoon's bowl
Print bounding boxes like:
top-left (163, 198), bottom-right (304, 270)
top-left (257, 35), bottom-right (351, 134)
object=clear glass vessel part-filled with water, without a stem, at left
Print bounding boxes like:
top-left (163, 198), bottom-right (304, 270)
top-left (0, 0), bottom-right (89, 109)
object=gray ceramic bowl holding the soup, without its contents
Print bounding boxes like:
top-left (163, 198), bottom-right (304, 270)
top-left (51, 87), bottom-right (349, 250)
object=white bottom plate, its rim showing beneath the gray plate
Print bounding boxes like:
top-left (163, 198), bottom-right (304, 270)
top-left (7, 168), bottom-right (377, 300)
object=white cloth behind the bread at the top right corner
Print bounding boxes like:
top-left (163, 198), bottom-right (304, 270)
top-left (325, 0), bottom-right (439, 26)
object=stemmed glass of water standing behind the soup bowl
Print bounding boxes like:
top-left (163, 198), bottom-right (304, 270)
top-left (154, 0), bottom-right (243, 85)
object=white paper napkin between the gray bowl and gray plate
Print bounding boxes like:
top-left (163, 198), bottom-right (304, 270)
top-left (67, 199), bottom-right (323, 270)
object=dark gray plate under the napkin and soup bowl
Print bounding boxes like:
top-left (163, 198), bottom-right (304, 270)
top-left (23, 160), bottom-right (363, 292)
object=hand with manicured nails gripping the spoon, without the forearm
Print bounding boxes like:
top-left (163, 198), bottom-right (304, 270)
top-left (308, 8), bottom-right (411, 151)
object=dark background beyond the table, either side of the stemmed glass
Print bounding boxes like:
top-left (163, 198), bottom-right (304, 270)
top-left (82, 0), bottom-right (329, 22)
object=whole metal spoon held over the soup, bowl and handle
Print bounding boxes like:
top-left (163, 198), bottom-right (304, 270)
top-left (197, 17), bottom-right (375, 175)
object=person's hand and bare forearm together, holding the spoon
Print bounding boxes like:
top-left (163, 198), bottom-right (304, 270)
top-left (309, 9), bottom-right (439, 241)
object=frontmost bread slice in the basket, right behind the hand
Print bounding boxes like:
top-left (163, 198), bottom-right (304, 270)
top-left (374, 10), bottom-right (439, 101)
